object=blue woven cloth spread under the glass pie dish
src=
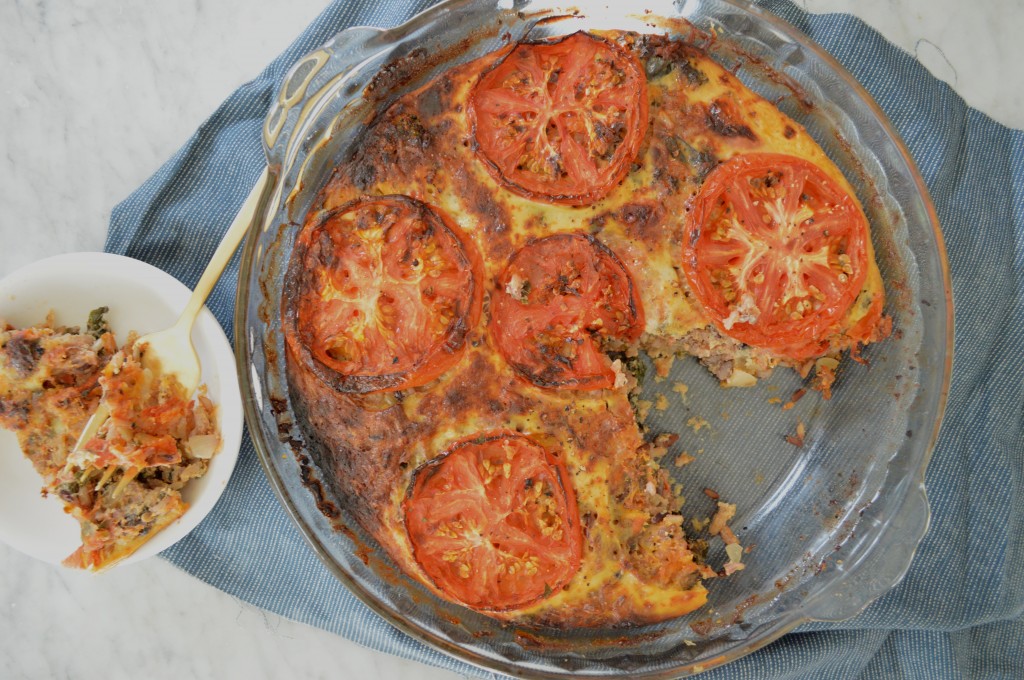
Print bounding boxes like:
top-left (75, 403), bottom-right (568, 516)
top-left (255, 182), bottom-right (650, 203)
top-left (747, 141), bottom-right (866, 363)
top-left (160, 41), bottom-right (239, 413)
top-left (106, 0), bottom-right (1024, 679)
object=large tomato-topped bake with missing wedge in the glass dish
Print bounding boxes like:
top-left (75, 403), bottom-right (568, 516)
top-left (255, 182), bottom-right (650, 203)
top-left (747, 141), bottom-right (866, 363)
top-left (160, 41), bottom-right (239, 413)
top-left (282, 32), bottom-right (889, 627)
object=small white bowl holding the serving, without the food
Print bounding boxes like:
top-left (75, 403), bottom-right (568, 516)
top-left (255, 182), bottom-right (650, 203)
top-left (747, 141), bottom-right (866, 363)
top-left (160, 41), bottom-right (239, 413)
top-left (0, 253), bottom-right (243, 565)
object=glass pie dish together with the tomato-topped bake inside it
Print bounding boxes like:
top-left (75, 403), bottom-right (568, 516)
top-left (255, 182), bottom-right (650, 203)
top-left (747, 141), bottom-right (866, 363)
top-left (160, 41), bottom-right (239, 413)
top-left (236, 0), bottom-right (952, 677)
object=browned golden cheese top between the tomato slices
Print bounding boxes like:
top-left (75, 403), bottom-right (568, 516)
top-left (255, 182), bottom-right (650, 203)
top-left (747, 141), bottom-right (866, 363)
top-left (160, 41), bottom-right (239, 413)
top-left (285, 33), bottom-right (881, 626)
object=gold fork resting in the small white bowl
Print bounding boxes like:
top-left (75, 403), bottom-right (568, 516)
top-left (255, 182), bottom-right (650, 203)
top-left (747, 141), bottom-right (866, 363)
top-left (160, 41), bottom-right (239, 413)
top-left (72, 168), bottom-right (268, 453)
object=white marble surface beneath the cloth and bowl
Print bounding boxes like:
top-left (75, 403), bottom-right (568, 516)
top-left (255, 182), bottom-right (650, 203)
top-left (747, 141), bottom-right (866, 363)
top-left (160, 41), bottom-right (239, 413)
top-left (0, 0), bottom-right (1024, 680)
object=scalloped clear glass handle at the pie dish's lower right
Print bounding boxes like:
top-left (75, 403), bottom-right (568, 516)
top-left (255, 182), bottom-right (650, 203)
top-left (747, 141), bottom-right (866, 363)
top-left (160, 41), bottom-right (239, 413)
top-left (804, 480), bottom-right (931, 622)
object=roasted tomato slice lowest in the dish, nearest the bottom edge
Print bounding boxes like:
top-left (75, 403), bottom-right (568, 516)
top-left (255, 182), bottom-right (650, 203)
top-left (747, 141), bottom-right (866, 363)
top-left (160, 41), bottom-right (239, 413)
top-left (404, 431), bottom-right (583, 610)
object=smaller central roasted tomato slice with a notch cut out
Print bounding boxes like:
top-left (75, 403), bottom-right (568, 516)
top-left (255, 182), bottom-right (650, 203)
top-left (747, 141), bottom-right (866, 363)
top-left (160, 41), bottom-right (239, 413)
top-left (490, 233), bottom-right (643, 389)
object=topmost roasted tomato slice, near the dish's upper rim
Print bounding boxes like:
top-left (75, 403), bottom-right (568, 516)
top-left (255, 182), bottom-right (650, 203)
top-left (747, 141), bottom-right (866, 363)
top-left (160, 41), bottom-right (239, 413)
top-left (469, 33), bottom-right (648, 205)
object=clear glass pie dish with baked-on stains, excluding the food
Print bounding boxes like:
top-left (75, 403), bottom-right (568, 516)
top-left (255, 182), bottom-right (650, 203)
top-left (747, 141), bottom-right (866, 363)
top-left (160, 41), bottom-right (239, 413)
top-left (236, 0), bottom-right (952, 677)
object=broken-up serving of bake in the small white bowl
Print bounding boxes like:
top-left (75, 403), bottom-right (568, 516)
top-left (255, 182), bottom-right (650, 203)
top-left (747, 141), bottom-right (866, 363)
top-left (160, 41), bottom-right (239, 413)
top-left (0, 307), bottom-right (220, 570)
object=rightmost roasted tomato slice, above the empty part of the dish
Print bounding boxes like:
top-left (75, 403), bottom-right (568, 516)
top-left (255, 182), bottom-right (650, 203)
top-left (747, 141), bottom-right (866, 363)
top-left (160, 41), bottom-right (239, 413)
top-left (683, 154), bottom-right (868, 359)
